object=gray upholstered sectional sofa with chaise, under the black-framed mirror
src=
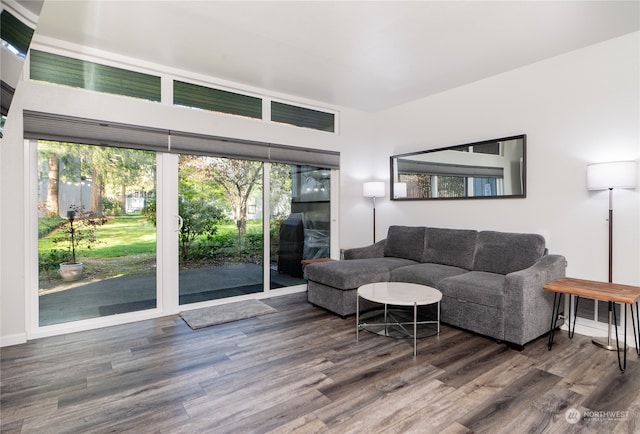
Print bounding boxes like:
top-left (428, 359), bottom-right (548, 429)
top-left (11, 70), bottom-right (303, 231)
top-left (305, 226), bottom-right (567, 349)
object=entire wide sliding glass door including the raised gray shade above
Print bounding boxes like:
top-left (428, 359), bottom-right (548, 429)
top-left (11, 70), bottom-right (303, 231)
top-left (25, 113), bottom-right (339, 334)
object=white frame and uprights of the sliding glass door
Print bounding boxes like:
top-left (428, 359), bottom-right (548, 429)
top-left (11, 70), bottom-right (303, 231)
top-left (24, 144), bottom-right (339, 340)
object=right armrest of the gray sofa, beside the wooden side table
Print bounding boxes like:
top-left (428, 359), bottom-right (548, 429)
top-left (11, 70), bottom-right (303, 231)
top-left (504, 255), bottom-right (567, 345)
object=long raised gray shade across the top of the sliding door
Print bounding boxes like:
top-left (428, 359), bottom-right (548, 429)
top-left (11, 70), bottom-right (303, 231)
top-left (24, 111), bottom-right (340, 168)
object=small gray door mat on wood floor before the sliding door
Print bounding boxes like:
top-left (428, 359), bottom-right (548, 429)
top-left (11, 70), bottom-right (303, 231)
top-left (179, 300), bottom-right (277, 330)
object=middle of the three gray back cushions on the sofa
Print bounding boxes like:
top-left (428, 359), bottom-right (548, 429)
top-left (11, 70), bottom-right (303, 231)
top-left (422, 228), bottom-right (478, 270)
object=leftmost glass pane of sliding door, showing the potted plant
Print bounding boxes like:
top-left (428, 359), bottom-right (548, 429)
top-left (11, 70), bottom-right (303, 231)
top-left (37, 141), bottom-right (157, 326)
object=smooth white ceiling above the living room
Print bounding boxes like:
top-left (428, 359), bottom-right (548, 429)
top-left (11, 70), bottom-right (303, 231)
top-left (34, 0), bottom-right (640, 111)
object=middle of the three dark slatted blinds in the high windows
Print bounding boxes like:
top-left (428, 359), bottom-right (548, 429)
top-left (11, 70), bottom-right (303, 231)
top-left (173, 80), bottom-right (262, 119)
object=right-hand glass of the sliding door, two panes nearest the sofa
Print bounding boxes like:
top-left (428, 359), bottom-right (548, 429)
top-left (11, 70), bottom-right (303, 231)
top-left (177, 158), bottom-right (331, 305)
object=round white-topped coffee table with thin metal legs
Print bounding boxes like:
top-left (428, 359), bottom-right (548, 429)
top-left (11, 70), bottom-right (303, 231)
top-left (356, 282), bottom-right (442, 357)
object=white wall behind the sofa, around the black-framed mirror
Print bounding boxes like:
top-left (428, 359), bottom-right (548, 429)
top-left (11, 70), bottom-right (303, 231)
top-left (341, 32), bottom-right (640, 285)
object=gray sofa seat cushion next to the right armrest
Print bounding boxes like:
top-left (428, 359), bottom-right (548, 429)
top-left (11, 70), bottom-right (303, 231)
top-left (438, 271), bottom-right (506, 308)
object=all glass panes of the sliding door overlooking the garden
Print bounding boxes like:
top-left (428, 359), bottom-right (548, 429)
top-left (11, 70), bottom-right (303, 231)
top-left (37, 141), bottom-right (331, 326)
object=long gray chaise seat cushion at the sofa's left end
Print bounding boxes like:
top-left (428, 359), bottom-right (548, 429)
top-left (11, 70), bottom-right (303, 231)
top-left (304, 258), bottom-right (417, 289)
